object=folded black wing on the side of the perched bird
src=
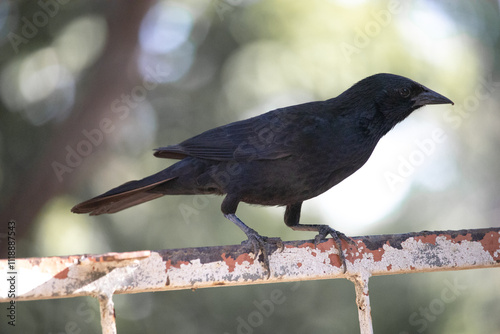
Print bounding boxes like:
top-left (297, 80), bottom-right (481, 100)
top-left (154, 102), bottom-right (323, 161)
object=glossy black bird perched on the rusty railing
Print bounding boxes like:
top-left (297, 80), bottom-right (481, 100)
top-left (71, 74), bottom-right (453, 272)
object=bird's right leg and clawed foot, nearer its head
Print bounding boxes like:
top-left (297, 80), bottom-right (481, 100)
top-left (285, 202), bottom-right (355, 273)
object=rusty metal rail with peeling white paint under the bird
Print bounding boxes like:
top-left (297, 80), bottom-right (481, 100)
top-left (0, 228), bottom-right (500, 334)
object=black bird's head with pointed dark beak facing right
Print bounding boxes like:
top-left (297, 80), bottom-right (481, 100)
top-left (345, 73), bottom-right (453, 131)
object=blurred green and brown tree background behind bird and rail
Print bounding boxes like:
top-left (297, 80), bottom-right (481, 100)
top-left (0, 0), bottom-right (500, 334)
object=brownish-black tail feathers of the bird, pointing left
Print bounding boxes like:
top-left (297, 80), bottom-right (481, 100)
top-left (71, 170), bottom-right (175, 216)
